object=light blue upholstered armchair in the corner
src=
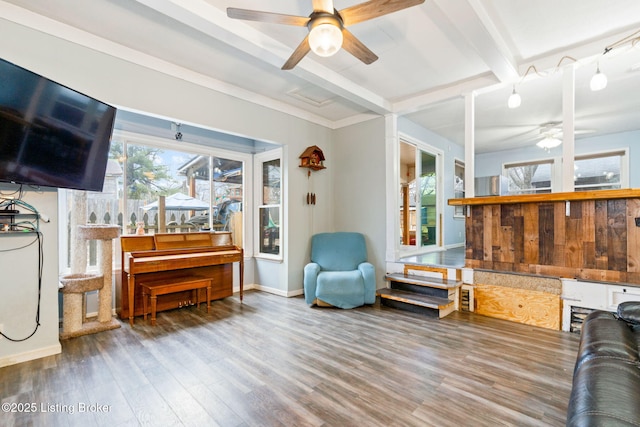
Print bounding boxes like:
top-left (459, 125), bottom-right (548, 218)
top-left (304, 232), bottom-right (376, 308)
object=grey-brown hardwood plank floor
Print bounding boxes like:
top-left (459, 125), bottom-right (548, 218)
top-left (0, 292), bottom-right (578, 427)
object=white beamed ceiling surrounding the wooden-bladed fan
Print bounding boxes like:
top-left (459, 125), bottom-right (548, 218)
top-left (0, 0), bottom-right (640, 152)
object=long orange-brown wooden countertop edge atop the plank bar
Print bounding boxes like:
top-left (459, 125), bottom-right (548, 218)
top-left (448, 188), bottom-right (640, 206)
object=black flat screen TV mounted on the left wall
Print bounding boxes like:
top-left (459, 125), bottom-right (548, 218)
top-left (0, 59), bottom-right (116, 191)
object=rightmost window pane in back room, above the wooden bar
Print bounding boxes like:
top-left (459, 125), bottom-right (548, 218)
top-left (574, 155), bottom-right (622, 191)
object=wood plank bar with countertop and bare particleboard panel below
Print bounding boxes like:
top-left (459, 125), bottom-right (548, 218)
top-left (449, 189), bottom-right (640, 328)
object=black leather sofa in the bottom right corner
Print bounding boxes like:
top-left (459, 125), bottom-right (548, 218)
top-left (567, 302), bottom-right (640, 426)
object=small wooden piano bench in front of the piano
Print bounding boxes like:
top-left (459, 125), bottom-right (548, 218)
top-left (139, 276), bottom-right (211, 326)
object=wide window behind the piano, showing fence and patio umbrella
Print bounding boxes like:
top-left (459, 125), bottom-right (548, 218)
top-left (61, 134), bottom-right (249, 268)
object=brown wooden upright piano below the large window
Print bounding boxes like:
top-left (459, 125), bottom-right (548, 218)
top-left (116, 232), bottom-right (244, 321)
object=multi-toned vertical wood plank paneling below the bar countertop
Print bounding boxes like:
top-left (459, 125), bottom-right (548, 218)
top-left (466, 198), bottom-right (640, 284)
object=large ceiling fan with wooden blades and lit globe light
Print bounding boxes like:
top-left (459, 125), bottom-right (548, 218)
top-left (227, 0), bottom-right (424, 70)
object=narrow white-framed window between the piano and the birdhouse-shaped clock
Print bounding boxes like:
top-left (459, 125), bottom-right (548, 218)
top-left (256, 150), bottom-right (282, 259)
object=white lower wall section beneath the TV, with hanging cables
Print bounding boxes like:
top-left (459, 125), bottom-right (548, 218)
top-left (0, 188), bottom-right (61, 367)
